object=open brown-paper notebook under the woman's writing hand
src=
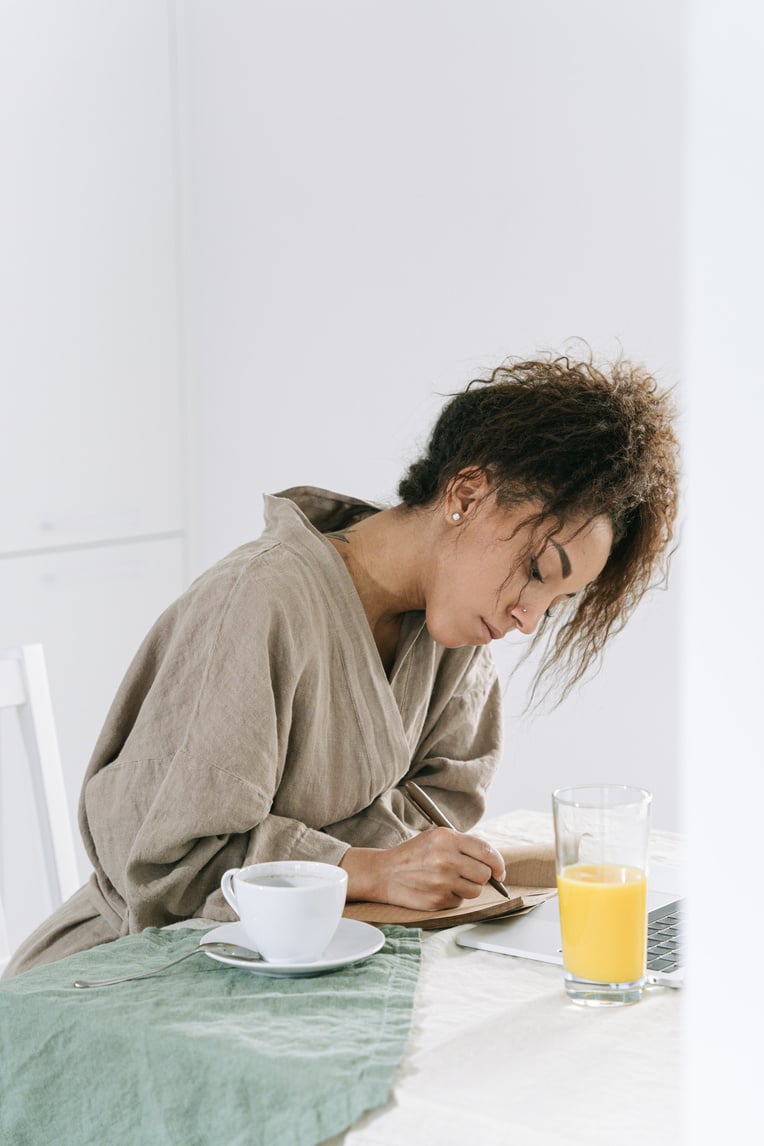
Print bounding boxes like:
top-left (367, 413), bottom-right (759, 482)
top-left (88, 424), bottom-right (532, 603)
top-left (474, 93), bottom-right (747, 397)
top-left (344, 843), bottom-right (557, 931)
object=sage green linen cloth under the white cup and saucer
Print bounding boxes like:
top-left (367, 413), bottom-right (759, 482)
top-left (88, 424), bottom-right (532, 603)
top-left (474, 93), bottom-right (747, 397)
top-left (0, 926), bottom-right (422, 1146)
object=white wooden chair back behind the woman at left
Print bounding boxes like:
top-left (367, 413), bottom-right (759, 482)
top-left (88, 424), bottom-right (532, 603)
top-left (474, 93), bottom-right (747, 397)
top-left (0, 644), bottom-right (81, 971)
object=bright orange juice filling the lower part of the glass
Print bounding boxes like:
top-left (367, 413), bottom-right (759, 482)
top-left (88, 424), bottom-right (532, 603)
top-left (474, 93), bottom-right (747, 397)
top-left (557, 864), bottom-right (647, 983)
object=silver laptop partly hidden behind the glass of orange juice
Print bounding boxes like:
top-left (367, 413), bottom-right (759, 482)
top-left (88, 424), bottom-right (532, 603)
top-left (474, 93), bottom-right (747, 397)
top-left (456, 864), bottom-right (685, 987)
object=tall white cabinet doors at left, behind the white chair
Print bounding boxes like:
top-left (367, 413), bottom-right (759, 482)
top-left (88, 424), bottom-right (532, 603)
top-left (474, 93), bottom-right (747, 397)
top-left (0, 0), bottom-right (184, 942)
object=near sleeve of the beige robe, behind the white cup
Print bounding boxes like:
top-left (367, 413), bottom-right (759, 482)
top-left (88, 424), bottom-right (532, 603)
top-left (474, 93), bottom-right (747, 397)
top-left (80, 550), bottom-right (348, 933)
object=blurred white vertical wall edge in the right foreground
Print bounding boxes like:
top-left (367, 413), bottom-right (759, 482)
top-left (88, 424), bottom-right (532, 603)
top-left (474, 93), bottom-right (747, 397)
top-left (680, 0), bottom-right (764, 1132)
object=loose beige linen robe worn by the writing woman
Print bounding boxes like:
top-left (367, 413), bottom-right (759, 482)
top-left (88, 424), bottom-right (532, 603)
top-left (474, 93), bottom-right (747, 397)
top-left (7, 487), bottom-right (502, 974)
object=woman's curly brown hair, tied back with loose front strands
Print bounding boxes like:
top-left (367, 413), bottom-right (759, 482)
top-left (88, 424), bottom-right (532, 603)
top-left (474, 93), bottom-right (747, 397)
top-left (397, 355), bottom-right (678, 698)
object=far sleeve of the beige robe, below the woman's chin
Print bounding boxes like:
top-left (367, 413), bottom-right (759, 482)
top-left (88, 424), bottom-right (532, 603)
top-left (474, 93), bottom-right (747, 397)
top-left (328, 647), bottom-right (503, 847)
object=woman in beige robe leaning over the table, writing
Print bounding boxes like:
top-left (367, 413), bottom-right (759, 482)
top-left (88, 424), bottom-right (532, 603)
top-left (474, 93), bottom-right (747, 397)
top-left (7, 350), bottom-right (677, 974)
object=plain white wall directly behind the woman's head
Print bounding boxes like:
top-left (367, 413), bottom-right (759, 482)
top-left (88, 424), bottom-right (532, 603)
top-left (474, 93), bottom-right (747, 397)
top-left (178, 0), bottom-right (683, 829)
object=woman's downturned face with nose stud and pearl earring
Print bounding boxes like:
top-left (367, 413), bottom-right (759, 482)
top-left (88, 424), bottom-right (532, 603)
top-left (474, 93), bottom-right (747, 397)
top-left (425, 495), bottom-right (613, 649)
